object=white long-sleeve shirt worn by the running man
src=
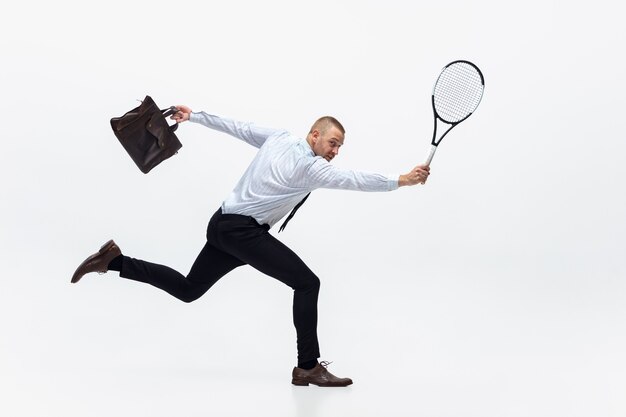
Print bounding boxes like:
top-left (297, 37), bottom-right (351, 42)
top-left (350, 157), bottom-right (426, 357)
top-left (189, 112), bottom-right (399, 227)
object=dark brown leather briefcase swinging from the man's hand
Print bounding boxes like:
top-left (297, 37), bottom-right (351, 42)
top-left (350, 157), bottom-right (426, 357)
top-left (111, 96), bottom-right (183, 174)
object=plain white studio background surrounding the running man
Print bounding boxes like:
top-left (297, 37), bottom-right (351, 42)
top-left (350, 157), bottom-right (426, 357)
top-left (0, 0), bottom-right (626, 417)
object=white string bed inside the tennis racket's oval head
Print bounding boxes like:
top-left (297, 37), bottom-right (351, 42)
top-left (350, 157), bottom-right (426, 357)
top-left (433, 62), bottom-right (484, 123)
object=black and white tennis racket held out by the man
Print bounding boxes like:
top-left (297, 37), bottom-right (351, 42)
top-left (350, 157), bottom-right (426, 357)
top-left (425, 60), bottom-right (485, 165)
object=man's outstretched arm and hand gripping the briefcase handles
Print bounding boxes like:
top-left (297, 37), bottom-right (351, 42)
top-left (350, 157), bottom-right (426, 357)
top-left (171, 105), bottom-right (282, 148)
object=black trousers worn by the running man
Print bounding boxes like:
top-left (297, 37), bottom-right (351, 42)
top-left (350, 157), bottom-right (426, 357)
top-left (120, 209), bottom-right (320, 363)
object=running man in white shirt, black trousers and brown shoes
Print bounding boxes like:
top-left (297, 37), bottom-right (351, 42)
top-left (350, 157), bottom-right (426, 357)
top-left (72, 106), bottom-right (430, 386)
